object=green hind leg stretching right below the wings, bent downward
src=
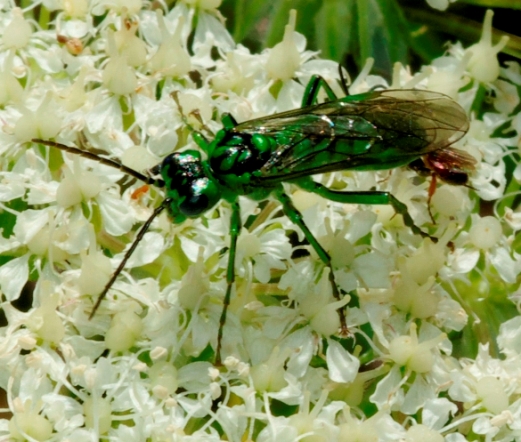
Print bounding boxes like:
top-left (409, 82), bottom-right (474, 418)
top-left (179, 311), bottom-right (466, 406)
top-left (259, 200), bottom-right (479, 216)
top-left (298, 180), bottom-right (438, 242)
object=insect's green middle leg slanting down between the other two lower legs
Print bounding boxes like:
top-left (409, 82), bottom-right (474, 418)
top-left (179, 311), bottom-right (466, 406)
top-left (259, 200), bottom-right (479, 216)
top-left (274, 188), bottom-right (348, 336)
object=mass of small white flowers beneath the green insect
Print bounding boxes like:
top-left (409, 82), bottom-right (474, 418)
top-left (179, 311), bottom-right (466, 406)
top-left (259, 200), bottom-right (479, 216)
top-left (0, 0), bottom-right (521, 442)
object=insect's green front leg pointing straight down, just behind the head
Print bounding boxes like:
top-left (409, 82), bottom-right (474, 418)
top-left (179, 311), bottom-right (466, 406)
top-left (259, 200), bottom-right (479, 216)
top-left (215, 201), bottom-right (241, 365)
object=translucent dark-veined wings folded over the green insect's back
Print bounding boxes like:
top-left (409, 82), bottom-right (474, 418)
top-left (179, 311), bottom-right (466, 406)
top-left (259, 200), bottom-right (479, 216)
top-left (233, 90), bottom-right (468, 181)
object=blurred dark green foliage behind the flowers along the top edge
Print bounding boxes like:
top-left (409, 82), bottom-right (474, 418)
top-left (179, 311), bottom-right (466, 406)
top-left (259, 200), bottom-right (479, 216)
top-left (220, 0), bottom-right (521, 77)
